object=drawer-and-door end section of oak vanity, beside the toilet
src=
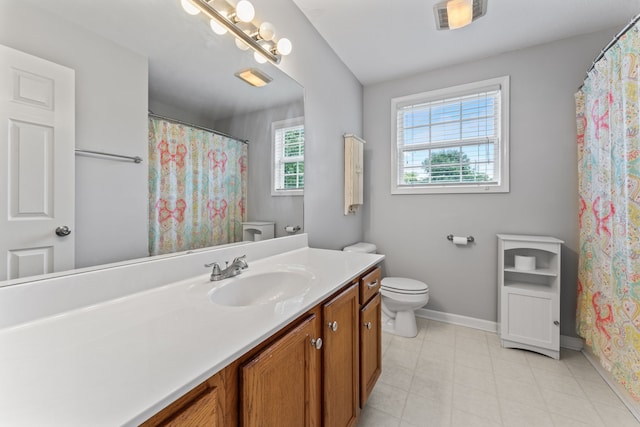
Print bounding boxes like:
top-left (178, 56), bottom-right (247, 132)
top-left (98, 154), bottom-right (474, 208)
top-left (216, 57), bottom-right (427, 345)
top-left (359, 267), bottom-right (382, 408)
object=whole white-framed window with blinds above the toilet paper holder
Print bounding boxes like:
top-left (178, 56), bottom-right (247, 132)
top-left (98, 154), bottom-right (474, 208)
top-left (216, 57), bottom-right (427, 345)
top-left (391, 76), bottom-right (509, 194)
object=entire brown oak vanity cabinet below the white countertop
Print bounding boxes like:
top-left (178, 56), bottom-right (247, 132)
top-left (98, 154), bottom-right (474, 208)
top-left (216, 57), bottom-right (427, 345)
top-left (143, 268), bottom-right (381, 427)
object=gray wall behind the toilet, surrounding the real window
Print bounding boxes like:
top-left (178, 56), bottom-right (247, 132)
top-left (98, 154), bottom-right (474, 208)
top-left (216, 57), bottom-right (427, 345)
top-left (364, 29), bottom-right (616, 336)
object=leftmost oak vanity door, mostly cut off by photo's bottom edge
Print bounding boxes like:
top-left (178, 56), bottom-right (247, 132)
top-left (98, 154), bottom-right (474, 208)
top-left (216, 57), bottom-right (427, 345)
top-left (142, 372), bottom-right (226, 427)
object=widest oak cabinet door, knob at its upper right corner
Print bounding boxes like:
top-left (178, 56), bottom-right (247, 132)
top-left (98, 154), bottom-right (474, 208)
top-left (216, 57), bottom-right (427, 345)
top-left (240, 315), bottom-right (320, 427)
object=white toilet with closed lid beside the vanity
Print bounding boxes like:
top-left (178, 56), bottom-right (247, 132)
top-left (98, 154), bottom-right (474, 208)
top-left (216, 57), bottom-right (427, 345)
top-left (343, 243), bottom-right (429, 338)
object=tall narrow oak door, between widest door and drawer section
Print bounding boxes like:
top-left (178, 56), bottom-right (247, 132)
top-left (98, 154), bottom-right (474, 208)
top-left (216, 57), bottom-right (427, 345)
top-left (322, 284), bottom-right (359, 427)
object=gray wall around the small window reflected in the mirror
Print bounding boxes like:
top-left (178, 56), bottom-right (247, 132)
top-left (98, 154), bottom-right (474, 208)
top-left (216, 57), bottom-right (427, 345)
top-left (215, 102), bottom-right (304, 237)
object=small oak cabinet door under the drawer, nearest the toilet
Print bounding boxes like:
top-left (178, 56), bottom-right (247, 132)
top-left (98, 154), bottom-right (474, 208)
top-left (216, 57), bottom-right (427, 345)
top-left (360, 294), bottom-right (382, 408)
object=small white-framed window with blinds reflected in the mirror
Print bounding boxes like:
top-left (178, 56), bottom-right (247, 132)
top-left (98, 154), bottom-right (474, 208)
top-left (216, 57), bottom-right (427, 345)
top-left (271, 117), bottom-right (304, 196)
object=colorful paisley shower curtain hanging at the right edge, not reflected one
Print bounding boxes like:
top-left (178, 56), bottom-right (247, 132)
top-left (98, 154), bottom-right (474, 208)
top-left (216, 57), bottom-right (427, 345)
top-left (576, 20), bottom-right (640, 400)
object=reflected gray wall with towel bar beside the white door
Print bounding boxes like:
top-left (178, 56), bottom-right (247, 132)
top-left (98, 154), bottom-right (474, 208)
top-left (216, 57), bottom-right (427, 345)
top-left (0, 0), bottom-right (149, 267)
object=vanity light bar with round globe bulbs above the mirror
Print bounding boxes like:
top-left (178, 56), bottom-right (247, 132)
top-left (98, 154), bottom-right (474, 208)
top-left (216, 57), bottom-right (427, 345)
top-left (180, 0), bottom-right (291, 64)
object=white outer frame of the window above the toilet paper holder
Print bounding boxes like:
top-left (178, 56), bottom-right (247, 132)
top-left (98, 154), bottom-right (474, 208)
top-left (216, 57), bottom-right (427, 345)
top-left (390, 76), bottom-right (509, 194)
